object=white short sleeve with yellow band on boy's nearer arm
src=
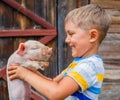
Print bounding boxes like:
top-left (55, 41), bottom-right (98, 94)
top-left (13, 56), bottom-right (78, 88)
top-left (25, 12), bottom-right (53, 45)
top-left (67, 63), bottom-right (96, 91)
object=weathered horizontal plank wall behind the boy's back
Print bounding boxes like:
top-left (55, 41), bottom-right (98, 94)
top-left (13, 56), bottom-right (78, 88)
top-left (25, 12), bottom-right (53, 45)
top-left (91, 0), bottom-right (120, 100)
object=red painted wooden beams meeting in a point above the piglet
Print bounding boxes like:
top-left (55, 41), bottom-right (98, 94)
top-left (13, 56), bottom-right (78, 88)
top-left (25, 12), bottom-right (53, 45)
top-left (0, 0), bottom-right (57, 44)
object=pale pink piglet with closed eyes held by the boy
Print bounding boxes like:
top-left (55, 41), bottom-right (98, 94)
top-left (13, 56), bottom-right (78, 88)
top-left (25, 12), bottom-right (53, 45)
top-left (7, 40), bottom-right (52, 100)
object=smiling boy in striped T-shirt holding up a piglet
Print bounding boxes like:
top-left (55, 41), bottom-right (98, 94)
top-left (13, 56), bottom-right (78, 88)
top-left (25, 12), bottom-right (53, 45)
top-left (8, 4), bottom-right (110, 100)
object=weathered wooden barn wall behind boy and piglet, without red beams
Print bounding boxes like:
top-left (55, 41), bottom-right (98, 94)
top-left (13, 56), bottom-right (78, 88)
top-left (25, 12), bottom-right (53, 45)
top-left (0, 0), bottom-right (120, 100)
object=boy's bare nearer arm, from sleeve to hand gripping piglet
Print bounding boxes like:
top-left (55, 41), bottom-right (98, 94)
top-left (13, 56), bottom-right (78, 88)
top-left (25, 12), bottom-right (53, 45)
top-left (8, 66), bottom-right (79, 100)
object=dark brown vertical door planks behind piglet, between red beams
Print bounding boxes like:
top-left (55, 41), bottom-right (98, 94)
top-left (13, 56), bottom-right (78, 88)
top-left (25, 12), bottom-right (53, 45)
top-left (0, 0), bottom-right (58, 100)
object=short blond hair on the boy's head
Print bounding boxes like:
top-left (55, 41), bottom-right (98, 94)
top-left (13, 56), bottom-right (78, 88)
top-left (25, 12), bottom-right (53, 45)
top-left (65, 4), bottom-right (111, 43)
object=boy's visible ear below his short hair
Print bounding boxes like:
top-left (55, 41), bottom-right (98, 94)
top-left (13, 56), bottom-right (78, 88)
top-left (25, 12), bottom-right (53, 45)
top-left (89, 29), bottom-right (99, 42)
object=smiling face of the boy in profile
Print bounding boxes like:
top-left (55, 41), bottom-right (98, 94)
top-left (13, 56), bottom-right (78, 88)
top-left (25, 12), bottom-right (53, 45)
top-left (65, 22), bottom-right (90, 57)
